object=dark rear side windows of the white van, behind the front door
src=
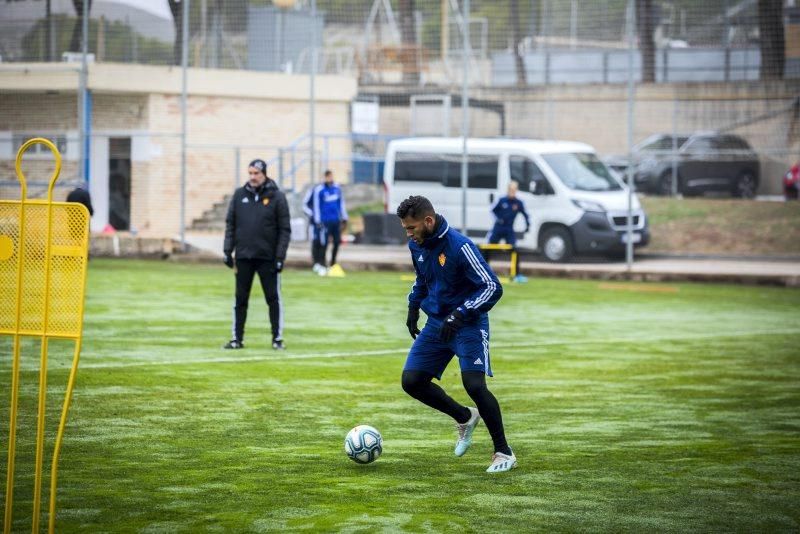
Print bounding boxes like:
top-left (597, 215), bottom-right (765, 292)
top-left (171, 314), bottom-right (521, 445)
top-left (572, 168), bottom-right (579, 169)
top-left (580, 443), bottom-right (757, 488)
top-left (394, 152), bottom-right (500, 189)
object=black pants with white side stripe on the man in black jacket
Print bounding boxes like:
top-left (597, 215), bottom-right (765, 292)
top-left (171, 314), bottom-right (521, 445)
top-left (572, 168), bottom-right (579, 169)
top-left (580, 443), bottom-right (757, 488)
top-left (233, 259), bottom-right (283, 341)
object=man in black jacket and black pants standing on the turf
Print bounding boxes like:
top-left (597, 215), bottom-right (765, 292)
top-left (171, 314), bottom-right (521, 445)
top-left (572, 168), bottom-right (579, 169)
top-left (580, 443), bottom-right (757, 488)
top-left (223, 159), bottom-right (292, 350)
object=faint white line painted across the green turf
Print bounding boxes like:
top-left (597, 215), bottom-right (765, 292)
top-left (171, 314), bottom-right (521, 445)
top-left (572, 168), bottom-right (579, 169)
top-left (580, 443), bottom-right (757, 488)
top-left (69, 328), bottom-right (800, 369)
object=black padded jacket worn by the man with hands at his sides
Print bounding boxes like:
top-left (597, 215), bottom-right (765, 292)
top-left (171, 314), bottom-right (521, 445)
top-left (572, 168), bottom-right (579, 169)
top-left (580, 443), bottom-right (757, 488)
top-left (223, 179), bottom-right (292, 261)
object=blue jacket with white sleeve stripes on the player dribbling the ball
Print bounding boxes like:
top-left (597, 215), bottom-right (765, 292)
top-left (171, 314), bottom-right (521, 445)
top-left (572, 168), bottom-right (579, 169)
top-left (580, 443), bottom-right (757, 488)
top-left (408, 215), bottom-right (503, 321)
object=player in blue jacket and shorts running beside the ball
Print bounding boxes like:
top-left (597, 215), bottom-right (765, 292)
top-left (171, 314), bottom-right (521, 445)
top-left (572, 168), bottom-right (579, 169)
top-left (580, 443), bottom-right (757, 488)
top-left (397, 196), bottom-right (517, 473)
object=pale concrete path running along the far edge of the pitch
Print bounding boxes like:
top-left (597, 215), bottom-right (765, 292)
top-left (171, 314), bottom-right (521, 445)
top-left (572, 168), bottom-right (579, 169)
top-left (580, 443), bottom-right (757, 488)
top-left (181, 233), bottom-right (800, 287)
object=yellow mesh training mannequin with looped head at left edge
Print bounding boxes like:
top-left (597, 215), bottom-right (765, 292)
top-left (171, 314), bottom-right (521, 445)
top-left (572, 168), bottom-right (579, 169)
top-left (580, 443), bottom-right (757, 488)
top-left (0, 138), bottom-right (89, 534)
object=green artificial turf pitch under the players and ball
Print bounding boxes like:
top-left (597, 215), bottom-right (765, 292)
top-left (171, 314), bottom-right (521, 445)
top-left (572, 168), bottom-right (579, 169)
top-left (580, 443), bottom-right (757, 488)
top-left (0, 260), bottom-right (800, 533)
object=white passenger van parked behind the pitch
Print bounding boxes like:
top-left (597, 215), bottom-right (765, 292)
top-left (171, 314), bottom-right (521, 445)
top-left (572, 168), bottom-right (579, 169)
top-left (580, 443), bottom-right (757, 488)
top-left (384, 137), bottom-right (650, 261)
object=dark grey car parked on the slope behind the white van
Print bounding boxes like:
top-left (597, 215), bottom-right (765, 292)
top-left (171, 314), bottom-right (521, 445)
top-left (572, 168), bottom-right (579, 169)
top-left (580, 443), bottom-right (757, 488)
top-left (606, 133), bottom-right (760, 198)
